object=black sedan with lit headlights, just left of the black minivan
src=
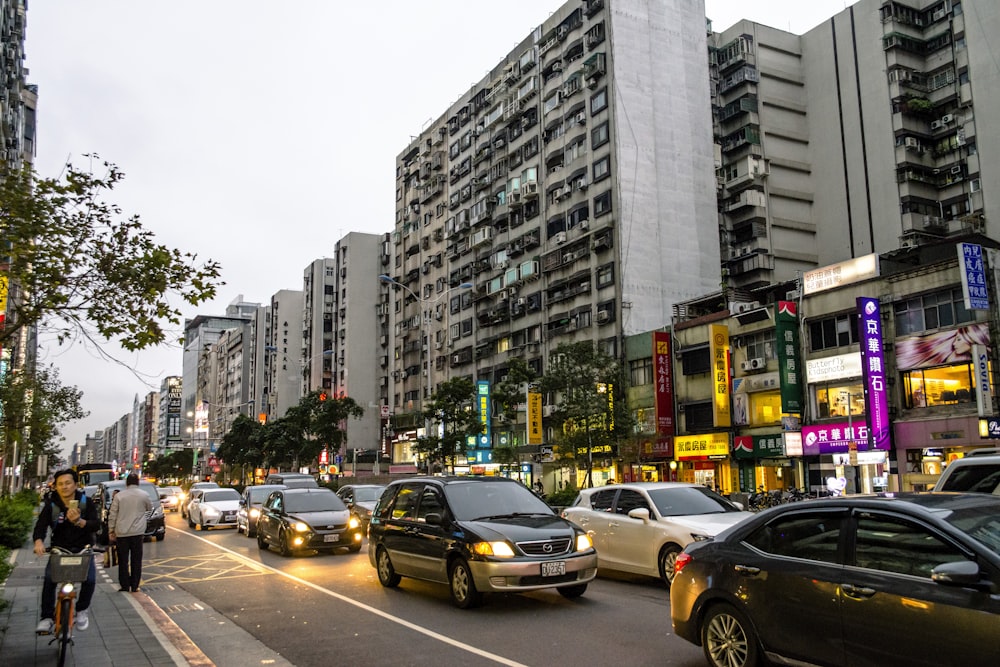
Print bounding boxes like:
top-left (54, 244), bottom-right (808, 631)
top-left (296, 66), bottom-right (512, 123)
top-left (257, 488), bottom-right (362, 556)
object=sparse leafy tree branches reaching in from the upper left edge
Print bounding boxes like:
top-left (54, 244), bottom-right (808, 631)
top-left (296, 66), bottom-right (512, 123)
top-left (0, 155), bottom-right (224, 350)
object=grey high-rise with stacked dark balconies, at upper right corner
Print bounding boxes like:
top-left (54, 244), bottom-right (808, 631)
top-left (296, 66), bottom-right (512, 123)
top-left (709, 0), bottom-right (1000, 289)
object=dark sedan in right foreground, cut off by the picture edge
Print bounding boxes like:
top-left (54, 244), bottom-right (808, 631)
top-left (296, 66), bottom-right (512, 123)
top-left (670, 493), bottom-right (1000, 667)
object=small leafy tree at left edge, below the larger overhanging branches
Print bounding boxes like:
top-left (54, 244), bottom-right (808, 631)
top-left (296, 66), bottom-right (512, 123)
top-left (0, 367), bottom-right (89, 475)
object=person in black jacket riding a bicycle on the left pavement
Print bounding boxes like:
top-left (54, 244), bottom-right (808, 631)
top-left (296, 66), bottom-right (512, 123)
top-left (32, 469), bottom-right (99, 634)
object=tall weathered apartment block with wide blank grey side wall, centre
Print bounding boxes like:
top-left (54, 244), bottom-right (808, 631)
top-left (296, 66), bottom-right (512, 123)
top-left (381, 0), bottom-right (720, 452)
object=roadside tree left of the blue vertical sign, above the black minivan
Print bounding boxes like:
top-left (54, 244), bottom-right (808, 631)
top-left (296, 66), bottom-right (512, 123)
top-left (414, 377), bottom-right (483, 472)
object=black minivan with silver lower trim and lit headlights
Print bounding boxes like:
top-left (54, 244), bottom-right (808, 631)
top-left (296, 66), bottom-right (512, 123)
top-left (368, 477), bottom-right (597, 609)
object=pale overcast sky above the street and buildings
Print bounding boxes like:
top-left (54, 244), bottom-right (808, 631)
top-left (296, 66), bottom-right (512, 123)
top-left (25, 0), bottom-right (848, 451)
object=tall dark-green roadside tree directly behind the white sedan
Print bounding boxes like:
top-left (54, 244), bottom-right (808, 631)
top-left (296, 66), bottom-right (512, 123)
top-left (541, 341), bottom-right (628, 487)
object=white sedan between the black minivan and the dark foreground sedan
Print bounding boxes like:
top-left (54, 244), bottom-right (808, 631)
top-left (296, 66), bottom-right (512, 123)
top-left (562, 482), bottom-right (753, 586)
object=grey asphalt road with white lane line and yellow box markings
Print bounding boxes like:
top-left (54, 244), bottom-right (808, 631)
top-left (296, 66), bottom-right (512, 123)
top-left (143, 514), bottom-right (705, 667)
